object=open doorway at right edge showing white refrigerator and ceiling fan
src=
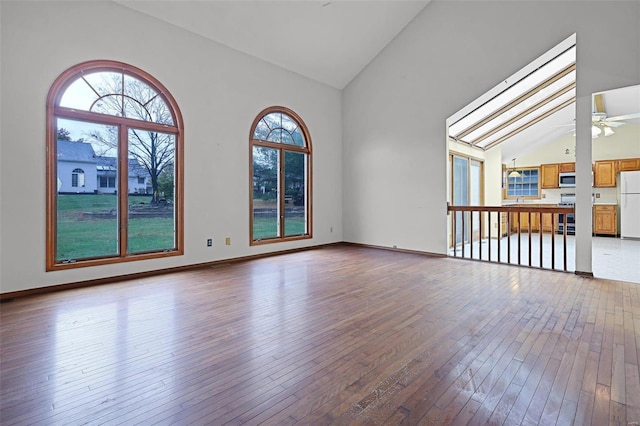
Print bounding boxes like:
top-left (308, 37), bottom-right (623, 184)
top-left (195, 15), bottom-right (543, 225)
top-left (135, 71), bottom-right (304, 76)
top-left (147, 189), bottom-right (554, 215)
top-left (591, 85), bottom-right (640, 283)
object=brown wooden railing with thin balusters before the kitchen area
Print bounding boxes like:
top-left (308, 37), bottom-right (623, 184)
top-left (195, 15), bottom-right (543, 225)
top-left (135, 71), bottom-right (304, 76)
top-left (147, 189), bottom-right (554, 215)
top-left (448, 206), bottom-right (575, 271)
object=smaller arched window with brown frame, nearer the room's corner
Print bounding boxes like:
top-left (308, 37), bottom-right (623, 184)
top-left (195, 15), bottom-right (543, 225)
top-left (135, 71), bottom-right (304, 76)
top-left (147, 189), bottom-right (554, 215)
top-left (249, 107), bottom-right (311, 245)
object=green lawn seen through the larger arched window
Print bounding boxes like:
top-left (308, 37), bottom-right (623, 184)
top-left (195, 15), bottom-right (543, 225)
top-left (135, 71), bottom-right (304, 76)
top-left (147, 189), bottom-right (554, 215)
top-left (56, 194), bottom-right (175, 260)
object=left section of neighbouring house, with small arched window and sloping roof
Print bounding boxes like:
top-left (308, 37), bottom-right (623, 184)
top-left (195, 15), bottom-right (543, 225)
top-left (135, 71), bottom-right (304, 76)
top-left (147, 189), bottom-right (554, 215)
top-left (58, 140), bottom-right (97, 193)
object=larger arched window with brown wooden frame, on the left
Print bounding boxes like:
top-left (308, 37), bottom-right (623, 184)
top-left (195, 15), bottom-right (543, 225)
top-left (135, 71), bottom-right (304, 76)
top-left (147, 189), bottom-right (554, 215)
top-left (47, 60), bottom-right (183, 270)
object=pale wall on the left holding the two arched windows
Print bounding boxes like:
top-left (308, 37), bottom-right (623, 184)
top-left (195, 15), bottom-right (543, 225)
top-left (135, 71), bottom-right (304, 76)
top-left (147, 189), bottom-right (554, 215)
top-left (0, 1), bottom-right (343, 293)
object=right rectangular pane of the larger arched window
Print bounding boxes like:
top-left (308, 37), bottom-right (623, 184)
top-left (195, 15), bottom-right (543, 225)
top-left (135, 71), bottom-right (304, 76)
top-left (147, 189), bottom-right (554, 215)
top-left (127, 129), bottom-right (176, 253)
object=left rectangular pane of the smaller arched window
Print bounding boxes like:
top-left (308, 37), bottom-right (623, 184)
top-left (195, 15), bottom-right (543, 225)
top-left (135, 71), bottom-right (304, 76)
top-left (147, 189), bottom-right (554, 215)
top-left (252, 146), bottom-right (280, 240)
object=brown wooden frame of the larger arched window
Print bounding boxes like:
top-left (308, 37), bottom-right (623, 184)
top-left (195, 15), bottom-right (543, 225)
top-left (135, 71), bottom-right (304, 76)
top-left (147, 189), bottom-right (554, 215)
top-left (46, 60), bottom-right (184, 271)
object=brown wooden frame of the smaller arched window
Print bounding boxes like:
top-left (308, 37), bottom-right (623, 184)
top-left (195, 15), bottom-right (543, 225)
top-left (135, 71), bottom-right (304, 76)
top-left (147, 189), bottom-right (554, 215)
top-left (249, 106), bottom-right (313, 246)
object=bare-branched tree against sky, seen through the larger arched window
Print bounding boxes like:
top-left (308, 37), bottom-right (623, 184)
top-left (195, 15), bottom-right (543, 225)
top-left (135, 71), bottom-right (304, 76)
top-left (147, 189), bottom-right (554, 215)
top-left (90, 72), bottom-right (175, 203)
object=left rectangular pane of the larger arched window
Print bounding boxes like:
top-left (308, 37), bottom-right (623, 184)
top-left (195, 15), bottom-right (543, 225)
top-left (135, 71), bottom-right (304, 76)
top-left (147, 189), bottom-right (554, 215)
top-left (56, 119), bottom-right (119, 261)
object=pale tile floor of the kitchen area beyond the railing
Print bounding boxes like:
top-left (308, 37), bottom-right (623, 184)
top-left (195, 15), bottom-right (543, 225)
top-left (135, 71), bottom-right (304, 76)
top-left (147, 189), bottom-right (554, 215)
top-left (449, 233), bottom-right (640, 284)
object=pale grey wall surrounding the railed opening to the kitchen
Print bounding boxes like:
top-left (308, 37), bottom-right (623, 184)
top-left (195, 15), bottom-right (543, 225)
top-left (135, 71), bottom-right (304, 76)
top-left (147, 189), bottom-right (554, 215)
top-left (343, 1), bottom-right (640, 272)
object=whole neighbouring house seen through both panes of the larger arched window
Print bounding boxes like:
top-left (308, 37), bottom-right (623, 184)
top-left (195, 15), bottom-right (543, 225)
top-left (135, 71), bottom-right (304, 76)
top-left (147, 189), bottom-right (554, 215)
top-left (58, 140), bottom-right (151, 194)
